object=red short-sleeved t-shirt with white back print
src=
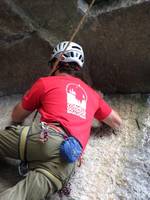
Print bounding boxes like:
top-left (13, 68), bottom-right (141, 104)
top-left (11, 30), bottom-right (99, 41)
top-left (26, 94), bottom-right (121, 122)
top-left (22, 75), bottom-right (112, 149)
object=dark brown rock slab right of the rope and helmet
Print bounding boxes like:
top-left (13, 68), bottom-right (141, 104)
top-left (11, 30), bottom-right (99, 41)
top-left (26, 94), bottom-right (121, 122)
top-left (80, 2), bottom-right (150, 93)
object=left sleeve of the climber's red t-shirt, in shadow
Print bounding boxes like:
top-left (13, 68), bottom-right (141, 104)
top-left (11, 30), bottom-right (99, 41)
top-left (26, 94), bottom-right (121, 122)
top-left (22, 79), bottom-right (44, 111)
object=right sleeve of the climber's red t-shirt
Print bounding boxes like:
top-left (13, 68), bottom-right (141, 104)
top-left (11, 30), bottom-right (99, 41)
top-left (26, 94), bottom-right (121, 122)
top-left (94, 97), bottom-right (112, 121)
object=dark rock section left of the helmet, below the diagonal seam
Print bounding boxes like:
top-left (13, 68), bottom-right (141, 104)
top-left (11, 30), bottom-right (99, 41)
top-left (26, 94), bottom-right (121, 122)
top-left (0, 1), bottom-right (51, 96)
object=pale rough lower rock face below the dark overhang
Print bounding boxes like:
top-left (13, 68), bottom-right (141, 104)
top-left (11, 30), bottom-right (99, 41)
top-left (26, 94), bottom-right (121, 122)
top-left (0, 95), bottom-right (150, 200)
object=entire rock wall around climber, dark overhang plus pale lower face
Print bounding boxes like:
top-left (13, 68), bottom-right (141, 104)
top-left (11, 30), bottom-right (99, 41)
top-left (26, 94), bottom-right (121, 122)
top-left (0, 0), bottom-right (150, 200)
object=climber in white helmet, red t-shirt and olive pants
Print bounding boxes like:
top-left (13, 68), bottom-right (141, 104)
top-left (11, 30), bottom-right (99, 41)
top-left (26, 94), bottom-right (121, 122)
top-left (0, 41), bottom-right (122, 200)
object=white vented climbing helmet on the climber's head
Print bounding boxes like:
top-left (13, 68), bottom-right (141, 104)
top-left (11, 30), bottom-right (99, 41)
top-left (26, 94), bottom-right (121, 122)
top-left (51, 41), bottom-right (84, 68)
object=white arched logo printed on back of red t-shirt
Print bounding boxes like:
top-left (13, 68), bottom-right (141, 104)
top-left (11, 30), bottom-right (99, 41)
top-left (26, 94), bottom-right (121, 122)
top-left (66, 83), bottom-right (87, 119)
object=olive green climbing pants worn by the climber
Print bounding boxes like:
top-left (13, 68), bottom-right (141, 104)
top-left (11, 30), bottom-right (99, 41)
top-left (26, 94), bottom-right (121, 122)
top-left (0, 125), bottom-right (75, 200)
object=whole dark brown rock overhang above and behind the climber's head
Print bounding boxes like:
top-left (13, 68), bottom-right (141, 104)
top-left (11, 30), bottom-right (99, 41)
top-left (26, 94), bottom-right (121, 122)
top-left (0, 0), bottom-right (150, 96)
